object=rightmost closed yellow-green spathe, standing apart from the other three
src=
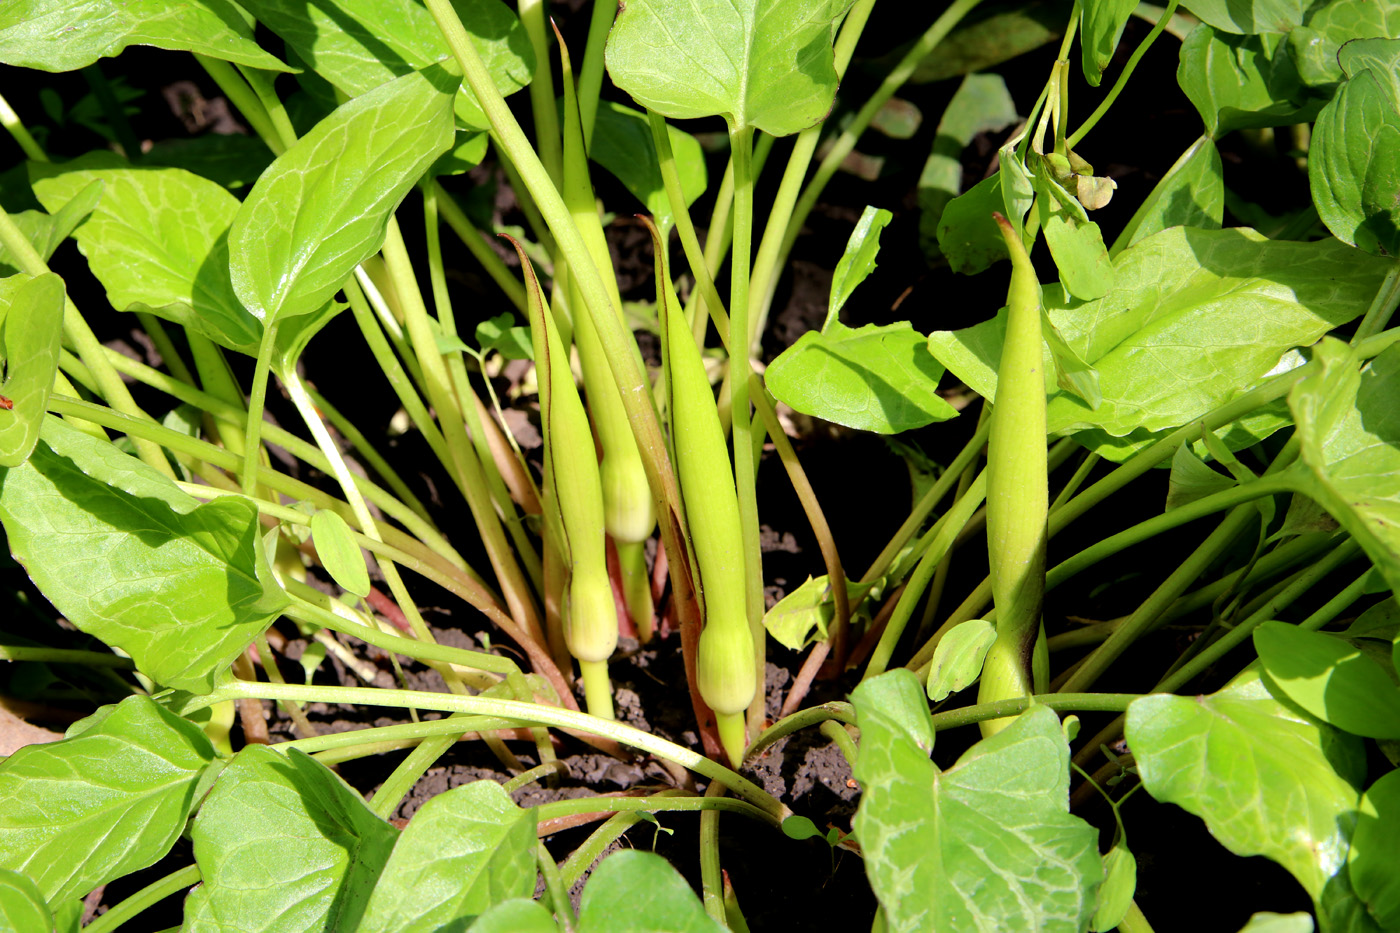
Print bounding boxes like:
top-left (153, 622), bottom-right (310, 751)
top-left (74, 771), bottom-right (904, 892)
top-left (977, 214), bottom-right (1050, 735)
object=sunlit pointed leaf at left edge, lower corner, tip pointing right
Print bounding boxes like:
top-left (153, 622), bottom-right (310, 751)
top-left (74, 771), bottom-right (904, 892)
top-left (0, 696), bottom-right (214, 902)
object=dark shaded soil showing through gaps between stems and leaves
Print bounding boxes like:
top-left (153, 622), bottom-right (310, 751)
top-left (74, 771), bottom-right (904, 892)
top-left (0, 4), bottom-right (1332, 932)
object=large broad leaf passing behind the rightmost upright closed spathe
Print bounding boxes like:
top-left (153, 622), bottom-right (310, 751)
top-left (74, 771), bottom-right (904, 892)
top-left (928, 227), bottom-right (1389, 439)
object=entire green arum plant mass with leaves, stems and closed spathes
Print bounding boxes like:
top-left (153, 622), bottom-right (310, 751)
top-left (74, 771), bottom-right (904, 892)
top-left (0, 0), bottom-right (1400, 933)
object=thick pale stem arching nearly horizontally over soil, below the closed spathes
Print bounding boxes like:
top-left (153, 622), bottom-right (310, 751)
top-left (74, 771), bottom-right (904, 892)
top-left (204, 681), bottom-right (790, 821)
